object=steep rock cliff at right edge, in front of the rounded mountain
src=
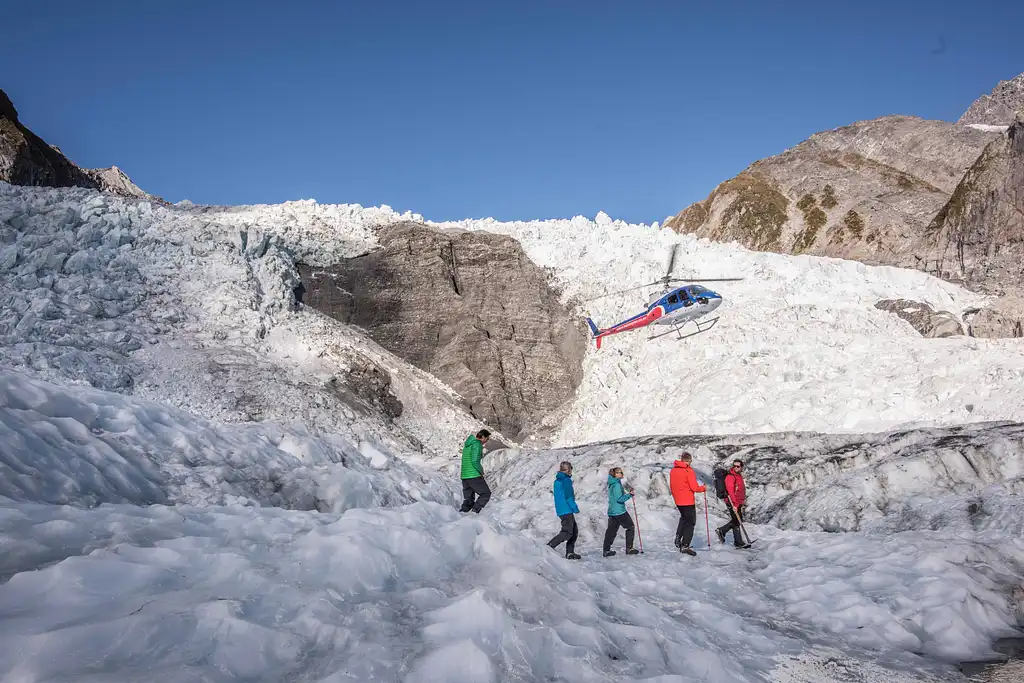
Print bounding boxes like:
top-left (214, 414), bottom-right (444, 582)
top-left (915, 121), bottom-right (1024, 337)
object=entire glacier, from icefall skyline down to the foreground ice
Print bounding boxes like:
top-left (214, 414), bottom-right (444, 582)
top-left (0, 183), bottom-right (1024, 683)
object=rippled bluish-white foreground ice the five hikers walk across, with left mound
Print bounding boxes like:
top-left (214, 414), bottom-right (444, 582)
top-left (0, 375), bottom-right (1024, 683)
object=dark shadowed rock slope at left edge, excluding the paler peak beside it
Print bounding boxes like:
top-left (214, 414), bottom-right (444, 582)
top-left (0, 90), bottom-right (99, 189)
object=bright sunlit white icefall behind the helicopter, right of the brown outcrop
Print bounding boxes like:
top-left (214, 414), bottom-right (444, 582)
top-left (428, 215), bottom-right (1024, 444)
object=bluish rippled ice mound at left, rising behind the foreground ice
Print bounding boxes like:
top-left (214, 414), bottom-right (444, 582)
top-left (0, 366), bottom-right (454, 512)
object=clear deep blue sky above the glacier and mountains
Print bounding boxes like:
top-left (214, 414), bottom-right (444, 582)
top-left (0, 0), bottom-right (1024, 222)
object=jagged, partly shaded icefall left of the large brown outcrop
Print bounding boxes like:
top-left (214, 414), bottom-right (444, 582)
top-left (0, 183), bottom-right (487, 466)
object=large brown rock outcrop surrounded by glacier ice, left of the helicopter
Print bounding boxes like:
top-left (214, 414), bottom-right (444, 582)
top-left (299, 222), bottom-right (586, 438)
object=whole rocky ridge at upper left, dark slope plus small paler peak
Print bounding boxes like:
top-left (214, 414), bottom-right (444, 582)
top-left (0, 90), bottom-right (155, 201)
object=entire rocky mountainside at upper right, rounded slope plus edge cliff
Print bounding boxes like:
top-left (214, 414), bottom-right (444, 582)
top-left (666, 74), bottom-right (1024, 337)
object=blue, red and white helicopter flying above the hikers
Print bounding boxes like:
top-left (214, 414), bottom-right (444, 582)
top-left (587, 244), bottom-right (742, 350)
